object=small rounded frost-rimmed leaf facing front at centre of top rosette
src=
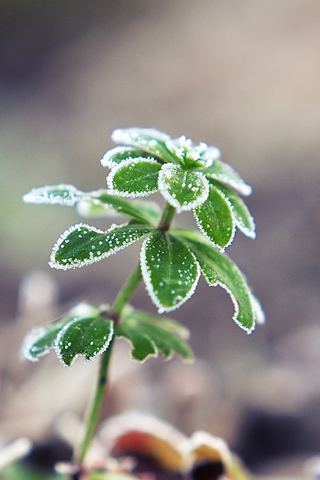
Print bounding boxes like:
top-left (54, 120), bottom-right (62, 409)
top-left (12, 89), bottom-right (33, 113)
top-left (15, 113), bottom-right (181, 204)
top-left (158, 163), bottom-right (209, 212)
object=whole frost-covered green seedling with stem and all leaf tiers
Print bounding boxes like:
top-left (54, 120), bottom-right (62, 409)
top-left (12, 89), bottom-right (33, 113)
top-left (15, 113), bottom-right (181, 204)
top-left (23, 128), bottom-right (264, 472)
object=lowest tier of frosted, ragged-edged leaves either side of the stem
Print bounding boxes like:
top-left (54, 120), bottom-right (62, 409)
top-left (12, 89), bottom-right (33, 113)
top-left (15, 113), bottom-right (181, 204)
top-left (22, 303), bottom-right (193, 367)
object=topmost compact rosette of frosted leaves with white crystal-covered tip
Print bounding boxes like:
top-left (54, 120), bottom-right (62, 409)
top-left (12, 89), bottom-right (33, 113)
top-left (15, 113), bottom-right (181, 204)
top-left (101, 128), bottom-right (255, 251)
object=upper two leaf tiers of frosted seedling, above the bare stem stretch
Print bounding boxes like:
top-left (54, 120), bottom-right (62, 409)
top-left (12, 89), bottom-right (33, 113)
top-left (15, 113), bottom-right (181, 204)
top-left (24, 128), bottom-right (263, 334)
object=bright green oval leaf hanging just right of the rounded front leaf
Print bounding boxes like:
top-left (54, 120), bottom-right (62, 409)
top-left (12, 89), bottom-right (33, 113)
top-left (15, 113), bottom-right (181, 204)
top-left (194, 185), bottom-right (235, 251)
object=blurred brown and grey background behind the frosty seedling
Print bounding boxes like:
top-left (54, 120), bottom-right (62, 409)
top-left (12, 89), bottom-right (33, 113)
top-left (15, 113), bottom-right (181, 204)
top-left (0, 0), bottom-right (320, 474)
